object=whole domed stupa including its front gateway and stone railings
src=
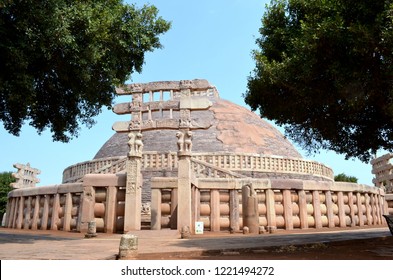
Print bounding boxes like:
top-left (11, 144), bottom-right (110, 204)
top-left (6, 80), bottom-right (393, 233)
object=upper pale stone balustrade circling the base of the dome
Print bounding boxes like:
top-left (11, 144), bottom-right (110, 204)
top-left (63, 152), bottom-right (334, 183)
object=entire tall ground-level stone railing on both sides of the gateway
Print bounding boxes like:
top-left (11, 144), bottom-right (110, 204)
top-left (5, 174), bottom-right (386, 233)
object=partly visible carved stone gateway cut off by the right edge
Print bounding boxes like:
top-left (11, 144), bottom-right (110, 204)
top-left (371, 153), bottom-right (393, 193)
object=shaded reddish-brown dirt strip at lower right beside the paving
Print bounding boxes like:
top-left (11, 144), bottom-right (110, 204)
top-left (137, 236), bottom-right (393, 260)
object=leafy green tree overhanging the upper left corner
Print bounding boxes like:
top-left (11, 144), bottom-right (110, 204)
top-left (0, 0), bottom-right (170, 142)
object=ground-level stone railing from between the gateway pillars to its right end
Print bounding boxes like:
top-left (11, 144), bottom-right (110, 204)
top-left (151, 178), bottom-right (388, 231)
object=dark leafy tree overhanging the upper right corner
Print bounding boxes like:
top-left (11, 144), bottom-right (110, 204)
top-left (244, 0), bottom-right (393, 162)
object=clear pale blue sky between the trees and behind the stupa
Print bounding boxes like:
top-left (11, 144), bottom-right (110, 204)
top-left (0, 0), bottom-right (374, 185)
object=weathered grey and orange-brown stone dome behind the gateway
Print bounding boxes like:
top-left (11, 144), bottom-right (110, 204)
top-left (94, 97), bottom-right (301, 159)
